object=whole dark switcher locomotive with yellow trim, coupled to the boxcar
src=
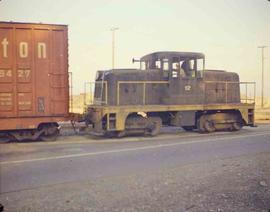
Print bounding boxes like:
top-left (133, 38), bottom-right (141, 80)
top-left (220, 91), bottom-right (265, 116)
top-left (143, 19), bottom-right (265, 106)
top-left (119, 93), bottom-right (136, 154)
top-left (85, 51), bottom-right (255, 137)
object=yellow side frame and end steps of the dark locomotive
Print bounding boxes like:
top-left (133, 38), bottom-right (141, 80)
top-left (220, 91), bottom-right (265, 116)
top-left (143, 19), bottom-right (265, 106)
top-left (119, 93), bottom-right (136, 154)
top-left (88, 103), bottom-right (254, 132)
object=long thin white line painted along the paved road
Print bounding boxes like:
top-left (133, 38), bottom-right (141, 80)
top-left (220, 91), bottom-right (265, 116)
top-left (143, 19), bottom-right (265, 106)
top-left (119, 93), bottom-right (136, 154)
top-left (0, 132), bottom-right (270, 165)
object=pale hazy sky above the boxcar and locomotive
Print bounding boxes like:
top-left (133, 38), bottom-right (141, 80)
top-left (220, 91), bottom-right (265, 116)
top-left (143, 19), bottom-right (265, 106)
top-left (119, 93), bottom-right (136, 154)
top-left (0, 0), bottom-right (270, 97)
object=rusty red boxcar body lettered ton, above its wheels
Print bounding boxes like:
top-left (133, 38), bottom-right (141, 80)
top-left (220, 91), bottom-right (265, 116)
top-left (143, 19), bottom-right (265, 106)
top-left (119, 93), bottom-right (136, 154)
top-left (0, 22), bottom-right (69, 130)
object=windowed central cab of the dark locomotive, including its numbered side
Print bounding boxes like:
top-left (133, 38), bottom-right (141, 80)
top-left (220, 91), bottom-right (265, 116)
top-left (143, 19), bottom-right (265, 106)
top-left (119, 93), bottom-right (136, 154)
top-left (137, 52), bottom-right (205, 104)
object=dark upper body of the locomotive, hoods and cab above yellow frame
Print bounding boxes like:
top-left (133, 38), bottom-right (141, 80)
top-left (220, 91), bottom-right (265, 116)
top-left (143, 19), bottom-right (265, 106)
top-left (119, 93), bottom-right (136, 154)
top-left (95, 52), bottom-right (247, 105)
